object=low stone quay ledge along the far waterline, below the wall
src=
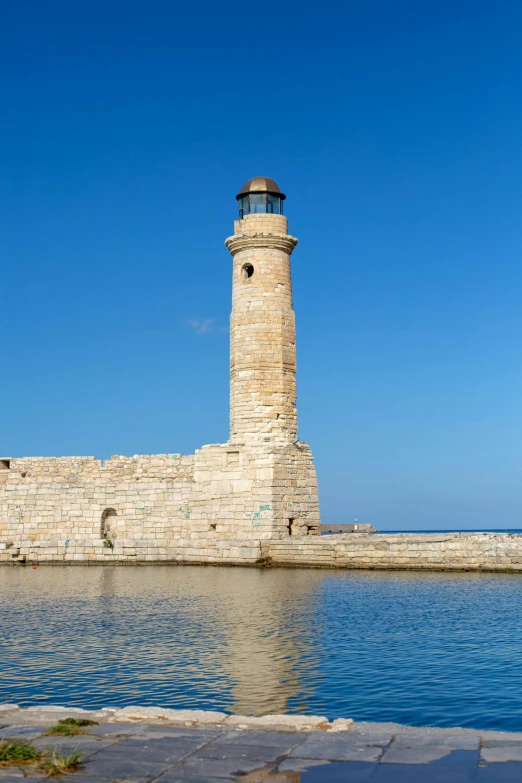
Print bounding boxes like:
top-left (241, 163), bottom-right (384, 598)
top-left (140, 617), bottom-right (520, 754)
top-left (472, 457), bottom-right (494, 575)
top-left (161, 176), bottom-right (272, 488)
top-left (0, 533), bottom-right (522, 572)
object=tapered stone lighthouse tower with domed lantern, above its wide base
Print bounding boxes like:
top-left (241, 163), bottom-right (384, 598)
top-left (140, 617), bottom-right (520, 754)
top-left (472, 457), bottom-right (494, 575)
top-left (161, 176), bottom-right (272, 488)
top-left (226, 177), bottom-right (297, 443)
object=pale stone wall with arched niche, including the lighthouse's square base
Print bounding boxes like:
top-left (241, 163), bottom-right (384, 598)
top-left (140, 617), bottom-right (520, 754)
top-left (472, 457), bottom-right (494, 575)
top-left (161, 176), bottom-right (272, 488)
top-left (0, 443), bottom-right (320, 562)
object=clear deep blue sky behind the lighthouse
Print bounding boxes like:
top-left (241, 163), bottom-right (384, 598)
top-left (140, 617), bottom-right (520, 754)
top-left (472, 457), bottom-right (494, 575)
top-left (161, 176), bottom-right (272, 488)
top-left (0, 0), bottom-right (522, 529)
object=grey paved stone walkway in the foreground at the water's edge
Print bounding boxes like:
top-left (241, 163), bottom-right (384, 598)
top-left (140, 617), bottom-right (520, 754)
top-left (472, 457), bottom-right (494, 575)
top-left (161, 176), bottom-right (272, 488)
top-left (0, 709), bottom-right (522, 783)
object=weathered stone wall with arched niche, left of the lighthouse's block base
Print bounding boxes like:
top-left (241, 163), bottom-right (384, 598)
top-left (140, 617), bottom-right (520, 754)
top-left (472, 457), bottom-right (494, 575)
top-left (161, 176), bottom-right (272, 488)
top-left (0, 454), bottom-right (194, 546)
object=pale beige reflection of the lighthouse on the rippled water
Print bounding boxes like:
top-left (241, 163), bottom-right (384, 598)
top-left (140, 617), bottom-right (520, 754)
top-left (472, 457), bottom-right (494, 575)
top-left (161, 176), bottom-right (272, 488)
top-left (206, 569), bottom-right (324, 715)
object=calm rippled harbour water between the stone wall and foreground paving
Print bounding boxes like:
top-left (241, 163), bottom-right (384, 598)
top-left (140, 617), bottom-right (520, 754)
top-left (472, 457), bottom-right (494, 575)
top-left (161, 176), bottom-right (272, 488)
top-left (0, 566), bottom-right (522, 731)
